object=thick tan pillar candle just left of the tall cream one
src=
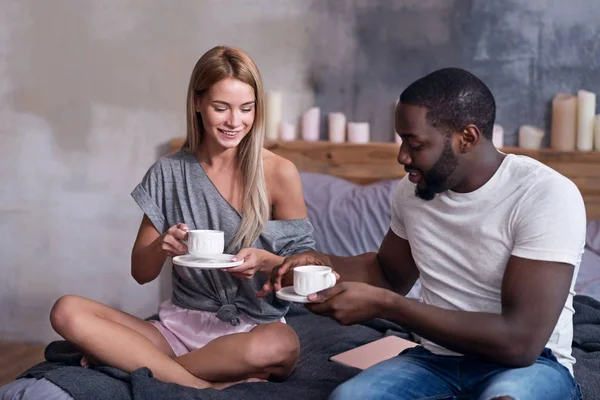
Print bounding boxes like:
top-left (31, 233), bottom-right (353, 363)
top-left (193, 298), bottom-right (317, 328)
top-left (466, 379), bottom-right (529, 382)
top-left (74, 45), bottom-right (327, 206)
top-left (550, 93), bottom-right (577, 151)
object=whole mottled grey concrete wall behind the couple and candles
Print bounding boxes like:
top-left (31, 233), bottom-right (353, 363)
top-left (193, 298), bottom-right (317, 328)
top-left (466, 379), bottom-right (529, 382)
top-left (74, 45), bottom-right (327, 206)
top-left (0, 0), bottom-right (600, 341)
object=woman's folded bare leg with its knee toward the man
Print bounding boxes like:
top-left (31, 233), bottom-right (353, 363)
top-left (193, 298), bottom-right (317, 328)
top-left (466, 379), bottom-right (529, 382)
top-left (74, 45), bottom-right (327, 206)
top-left (175, 322), bottom-right (300, 382)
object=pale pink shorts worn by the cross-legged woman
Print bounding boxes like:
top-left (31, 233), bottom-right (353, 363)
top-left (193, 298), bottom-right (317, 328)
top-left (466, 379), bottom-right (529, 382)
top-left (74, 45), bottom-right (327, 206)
top-left (150, 300), bottom-right (285, 357)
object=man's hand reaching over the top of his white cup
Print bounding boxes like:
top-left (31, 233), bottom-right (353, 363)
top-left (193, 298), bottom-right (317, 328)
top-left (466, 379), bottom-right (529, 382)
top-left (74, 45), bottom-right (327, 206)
top-left (256, 251), bottom-right (332, 297)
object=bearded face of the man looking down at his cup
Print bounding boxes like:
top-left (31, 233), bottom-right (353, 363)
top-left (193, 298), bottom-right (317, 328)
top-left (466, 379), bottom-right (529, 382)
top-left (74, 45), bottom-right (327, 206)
top-left (396, 103), bottom-right (458, 200)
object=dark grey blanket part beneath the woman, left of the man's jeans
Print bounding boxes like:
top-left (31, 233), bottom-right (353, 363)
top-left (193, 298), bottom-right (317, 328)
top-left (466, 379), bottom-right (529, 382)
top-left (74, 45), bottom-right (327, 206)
top-left (20, 306), bottom-right (390, 400)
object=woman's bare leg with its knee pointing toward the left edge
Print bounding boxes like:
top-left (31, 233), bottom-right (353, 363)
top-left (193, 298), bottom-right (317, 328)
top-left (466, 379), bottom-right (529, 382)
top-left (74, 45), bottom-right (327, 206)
top-left (50, 296), bottom-right (211, 388)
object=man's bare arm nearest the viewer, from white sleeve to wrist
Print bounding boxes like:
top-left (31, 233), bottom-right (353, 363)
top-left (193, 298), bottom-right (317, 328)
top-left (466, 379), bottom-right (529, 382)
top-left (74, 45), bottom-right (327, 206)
top-left (379, 256), bottom-right (574, 367)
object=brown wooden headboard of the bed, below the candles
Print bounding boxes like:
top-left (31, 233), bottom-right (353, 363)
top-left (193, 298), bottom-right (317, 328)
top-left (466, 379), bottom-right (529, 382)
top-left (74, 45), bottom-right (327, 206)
top-left (170, 138), bottom-right (600, 220)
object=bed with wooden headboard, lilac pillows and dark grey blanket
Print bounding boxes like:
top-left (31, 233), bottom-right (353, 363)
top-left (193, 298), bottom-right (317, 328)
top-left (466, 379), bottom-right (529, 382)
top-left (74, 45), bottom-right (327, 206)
top-left (0, 140), bottom-right (600, 400)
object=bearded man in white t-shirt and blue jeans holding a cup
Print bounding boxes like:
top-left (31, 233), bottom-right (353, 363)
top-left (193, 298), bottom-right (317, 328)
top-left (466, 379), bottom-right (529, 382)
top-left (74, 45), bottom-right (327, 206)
top-left (263, 68), bottom-right (586, 400)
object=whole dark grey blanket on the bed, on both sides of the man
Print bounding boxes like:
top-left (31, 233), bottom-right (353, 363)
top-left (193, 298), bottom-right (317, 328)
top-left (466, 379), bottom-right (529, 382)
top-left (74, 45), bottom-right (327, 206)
top-left (20, 296), bottom-right (600, 400)
